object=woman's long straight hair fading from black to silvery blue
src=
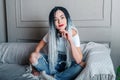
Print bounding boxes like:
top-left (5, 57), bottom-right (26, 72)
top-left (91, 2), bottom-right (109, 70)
top-left (48, 7), bottom-right (73, 74)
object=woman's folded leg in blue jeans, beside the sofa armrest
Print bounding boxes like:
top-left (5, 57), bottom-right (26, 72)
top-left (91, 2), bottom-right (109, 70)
top-left (54, 62), bottom-right (83, 80)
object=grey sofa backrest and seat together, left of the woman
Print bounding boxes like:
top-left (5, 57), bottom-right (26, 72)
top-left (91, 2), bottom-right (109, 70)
top-left (0, 43), bottom-right (36, 80)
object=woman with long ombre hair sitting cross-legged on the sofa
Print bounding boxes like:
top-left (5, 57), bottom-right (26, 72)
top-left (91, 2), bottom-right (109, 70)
top-left (29, 7), bottom-right (84, 80)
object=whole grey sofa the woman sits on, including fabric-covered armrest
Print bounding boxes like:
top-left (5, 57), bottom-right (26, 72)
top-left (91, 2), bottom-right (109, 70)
top-left (0, 42), bottom-right (115, 80)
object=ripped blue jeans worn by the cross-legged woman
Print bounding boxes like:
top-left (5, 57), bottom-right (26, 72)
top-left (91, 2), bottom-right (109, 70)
top-left (34, 54), bottom-right (83, 80)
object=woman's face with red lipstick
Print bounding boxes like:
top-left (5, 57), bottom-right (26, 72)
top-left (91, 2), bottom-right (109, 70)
top-left (54, 10), bottom-right (67, 30)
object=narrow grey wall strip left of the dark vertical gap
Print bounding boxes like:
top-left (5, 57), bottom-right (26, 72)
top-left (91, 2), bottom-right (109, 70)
top-left (0, 0), bottom-right (6, 43)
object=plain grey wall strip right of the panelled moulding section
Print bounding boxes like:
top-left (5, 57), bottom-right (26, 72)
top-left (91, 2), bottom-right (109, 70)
top-left (111, 0), bottom-right (120, 72)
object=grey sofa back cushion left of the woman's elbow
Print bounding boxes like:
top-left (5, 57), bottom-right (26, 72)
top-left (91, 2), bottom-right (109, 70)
top-left (0, 43), bottom-right (36, 64)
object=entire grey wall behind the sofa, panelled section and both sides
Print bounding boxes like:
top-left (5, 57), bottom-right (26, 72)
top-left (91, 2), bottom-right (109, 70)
top-left (0, 0), bottom-right (120, 70)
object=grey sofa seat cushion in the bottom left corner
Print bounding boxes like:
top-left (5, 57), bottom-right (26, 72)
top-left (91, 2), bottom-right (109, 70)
top-left (0, 64), bottom-right (32, 80)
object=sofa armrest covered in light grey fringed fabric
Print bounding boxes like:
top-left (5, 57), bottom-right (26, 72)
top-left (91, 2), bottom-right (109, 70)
top-left (76, 43), bottom-right (115, 80)
